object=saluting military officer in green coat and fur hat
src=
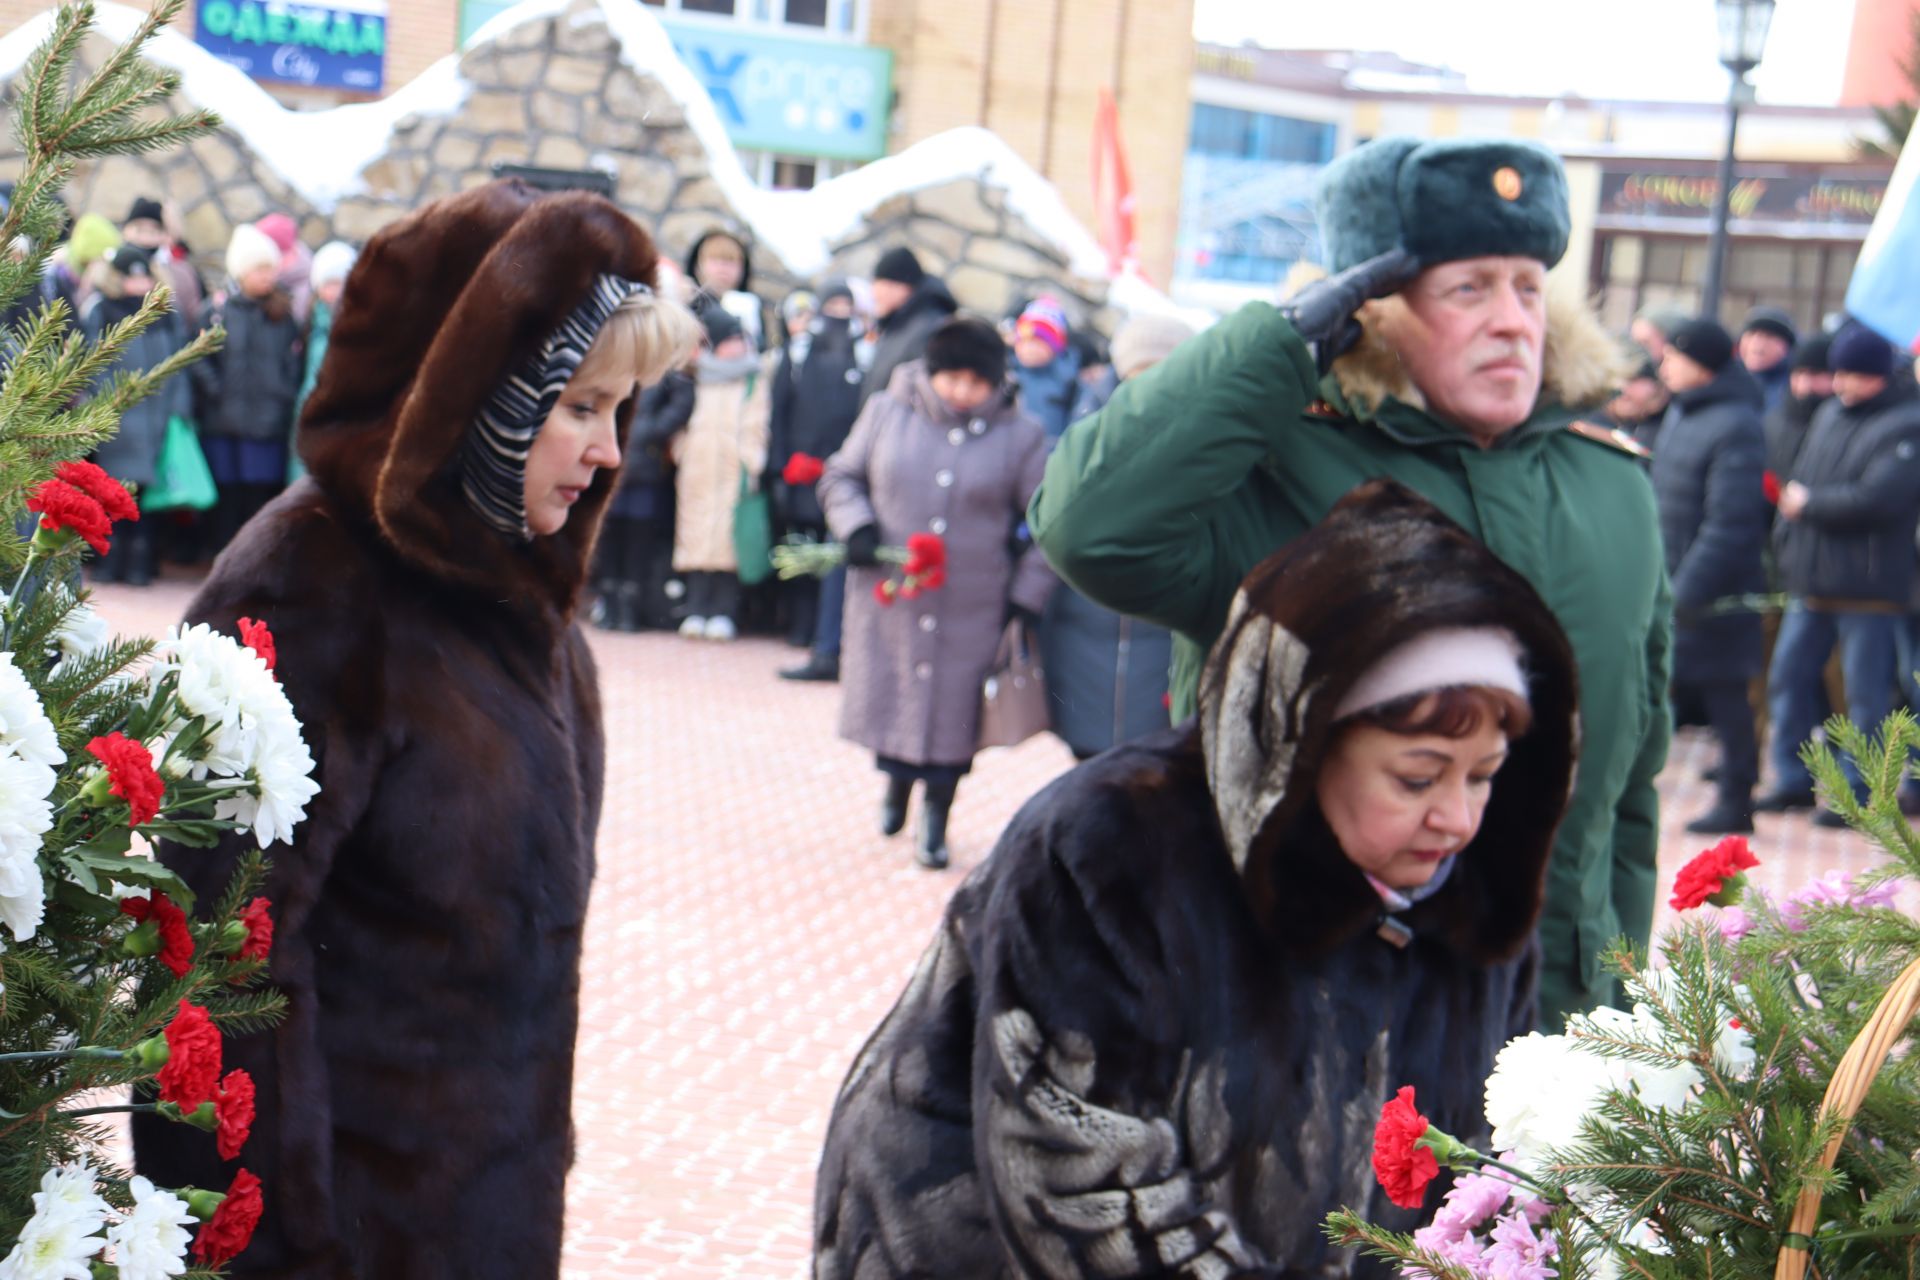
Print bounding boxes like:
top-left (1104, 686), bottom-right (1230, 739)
top-left (1031, 138), bottom-right (1672, 1029)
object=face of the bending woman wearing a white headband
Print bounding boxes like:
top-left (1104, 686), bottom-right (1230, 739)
top-left (1315, 718), bottom-right (1507, 889)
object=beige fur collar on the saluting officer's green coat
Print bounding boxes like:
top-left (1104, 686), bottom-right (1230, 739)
top-left (1332, 290), bottom-right (1634, 413)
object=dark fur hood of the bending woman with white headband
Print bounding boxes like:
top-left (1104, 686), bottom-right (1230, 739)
top-left (1200, 480), bottom-right (1578, 960)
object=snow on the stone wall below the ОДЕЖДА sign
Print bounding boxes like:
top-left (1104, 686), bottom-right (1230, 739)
top-left (0, 2), bottom-right (470, 211)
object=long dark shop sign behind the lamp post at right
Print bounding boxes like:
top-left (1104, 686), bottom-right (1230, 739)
top-left (1599, 169), bottom-right (1887, 226)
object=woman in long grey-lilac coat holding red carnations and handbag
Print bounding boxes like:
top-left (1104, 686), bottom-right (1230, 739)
top-left (820, 317), bottom-right (1054, 869)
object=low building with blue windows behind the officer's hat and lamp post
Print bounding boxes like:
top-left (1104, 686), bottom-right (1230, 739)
top-left (1173, 38), bottom-right (1891, 328)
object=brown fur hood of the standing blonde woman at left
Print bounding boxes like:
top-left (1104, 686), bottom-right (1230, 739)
top-left (298, 180), bottom-right (659, 616)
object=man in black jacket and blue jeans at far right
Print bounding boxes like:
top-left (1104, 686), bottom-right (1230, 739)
top-left (1755, 322), bottom-right (1920, 827)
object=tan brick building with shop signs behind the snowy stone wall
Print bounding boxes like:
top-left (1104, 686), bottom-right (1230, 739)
top-left (0, 0), bottom-right (1192, 284)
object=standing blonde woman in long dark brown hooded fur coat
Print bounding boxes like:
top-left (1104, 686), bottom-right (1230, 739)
top-left (134, 182), bottom-right (697, 1280)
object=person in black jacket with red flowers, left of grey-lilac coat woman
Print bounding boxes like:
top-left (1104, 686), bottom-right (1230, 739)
top-left (768, 280), bottom-right (872, 681)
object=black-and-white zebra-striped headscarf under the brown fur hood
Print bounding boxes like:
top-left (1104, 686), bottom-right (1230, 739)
top-left (459, 276), bottom-right (647, 541)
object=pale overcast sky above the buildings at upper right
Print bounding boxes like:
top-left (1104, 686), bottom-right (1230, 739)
top-left (1194, 0), bottom-right (1853, 106)
